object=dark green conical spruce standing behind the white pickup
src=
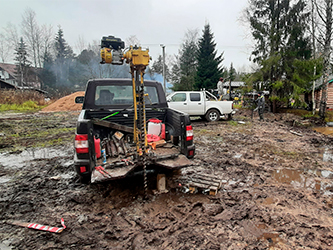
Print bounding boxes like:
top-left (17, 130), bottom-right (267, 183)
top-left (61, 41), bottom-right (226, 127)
top-left (195, 24), bottom-right (223, 89)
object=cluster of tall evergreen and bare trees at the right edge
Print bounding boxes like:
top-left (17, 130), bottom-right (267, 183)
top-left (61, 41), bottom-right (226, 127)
top-left (244, 0), bottom-right (333, 117)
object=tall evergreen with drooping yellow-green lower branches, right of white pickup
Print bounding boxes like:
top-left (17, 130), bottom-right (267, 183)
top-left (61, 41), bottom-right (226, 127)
top-left (247, 0), bottom-right (313, 112)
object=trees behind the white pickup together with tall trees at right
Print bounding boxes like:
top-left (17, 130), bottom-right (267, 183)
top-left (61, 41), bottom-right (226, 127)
top-left (158, 0), bottom-right (333, 118)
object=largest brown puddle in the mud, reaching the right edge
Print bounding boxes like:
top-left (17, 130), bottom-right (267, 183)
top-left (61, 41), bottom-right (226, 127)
top-left (272, 169), bottom-right (333, 195)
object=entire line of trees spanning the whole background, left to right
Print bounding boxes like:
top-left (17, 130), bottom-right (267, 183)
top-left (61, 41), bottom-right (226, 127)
top-left (0, 0), bottom-right (333, 116)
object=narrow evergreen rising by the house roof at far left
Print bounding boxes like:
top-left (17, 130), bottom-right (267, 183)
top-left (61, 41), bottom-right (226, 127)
top-left (14, 37), bottom-right (31, 86)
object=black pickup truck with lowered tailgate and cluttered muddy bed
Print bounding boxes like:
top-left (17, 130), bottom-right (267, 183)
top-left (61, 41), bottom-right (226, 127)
top-left (74, 79), bottom-right (195, 183)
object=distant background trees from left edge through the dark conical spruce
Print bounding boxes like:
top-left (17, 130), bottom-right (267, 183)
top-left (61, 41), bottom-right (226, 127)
top-left (0, 8), bottom-right (234, 95)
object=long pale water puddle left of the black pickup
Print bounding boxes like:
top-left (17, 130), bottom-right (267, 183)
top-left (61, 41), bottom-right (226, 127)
top-left (0, 148), bottom-right (72, 168)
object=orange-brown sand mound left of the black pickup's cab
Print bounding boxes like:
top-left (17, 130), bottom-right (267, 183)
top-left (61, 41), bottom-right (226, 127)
top-left (42, 91), bottom-right (84, 112)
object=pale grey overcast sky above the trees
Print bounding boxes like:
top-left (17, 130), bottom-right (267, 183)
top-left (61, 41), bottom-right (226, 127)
top-left (0, 0), bottom-right (251, 70)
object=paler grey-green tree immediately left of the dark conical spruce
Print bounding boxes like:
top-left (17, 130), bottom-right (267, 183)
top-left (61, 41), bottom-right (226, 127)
top-left (171, 30), bottom-right (198, 91)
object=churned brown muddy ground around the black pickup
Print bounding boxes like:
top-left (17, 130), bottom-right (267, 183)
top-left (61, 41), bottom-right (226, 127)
top-left (0, 111), bottom-right (333, 250)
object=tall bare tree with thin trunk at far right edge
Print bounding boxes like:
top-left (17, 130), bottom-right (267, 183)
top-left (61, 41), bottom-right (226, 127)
top-left (314, 0), bottom-right (333, 118)
